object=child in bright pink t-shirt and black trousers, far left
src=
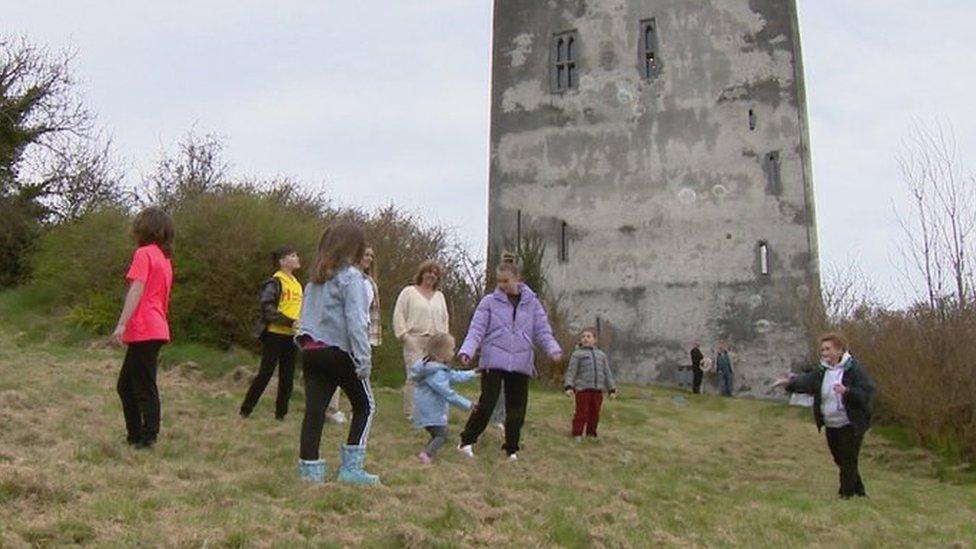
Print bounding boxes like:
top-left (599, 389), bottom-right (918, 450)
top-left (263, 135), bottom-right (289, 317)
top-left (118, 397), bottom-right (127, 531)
top-left (112, 207), bottom-right (174, 448)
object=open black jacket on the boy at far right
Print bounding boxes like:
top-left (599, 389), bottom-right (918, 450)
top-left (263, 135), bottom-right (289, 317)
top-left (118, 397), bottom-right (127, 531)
top-left (786, 357), bottom-right (874, 435)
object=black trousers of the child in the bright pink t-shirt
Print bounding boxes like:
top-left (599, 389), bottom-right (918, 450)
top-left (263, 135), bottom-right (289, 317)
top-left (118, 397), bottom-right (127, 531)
top-left (115, 341), bottom-right (163, 444)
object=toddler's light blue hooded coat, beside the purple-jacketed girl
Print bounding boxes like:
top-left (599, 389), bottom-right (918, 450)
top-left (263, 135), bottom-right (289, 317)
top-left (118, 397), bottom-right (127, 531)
top-left (410, 359), bottom-right (478, 427)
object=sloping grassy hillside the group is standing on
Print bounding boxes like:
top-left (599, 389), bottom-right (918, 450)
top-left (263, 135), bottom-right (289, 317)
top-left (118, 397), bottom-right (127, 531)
top-left (0, 288), bottom-right (976, 547)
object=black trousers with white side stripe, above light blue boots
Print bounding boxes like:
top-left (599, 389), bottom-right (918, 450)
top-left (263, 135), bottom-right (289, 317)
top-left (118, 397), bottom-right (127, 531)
top-left (299, 347), bottom-right (376, 461)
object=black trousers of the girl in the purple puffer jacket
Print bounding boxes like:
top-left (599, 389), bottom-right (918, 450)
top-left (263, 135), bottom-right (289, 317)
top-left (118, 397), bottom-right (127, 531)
top-left (461, 370), bottom-right (529, 455)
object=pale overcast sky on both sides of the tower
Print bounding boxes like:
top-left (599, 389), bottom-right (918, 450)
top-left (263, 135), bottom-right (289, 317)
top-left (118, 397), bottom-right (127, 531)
top-left (0, 0), bottom-right (976, 302)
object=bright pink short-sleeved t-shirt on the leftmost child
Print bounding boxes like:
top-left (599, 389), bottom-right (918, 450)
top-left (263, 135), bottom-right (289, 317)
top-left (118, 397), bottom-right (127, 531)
top-left (122, 244), bottom-right (173, 343)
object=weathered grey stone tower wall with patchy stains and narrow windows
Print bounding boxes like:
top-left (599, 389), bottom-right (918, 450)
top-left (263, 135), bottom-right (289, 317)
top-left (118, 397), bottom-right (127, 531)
top-left (489, 0), bottom-right (819, 395)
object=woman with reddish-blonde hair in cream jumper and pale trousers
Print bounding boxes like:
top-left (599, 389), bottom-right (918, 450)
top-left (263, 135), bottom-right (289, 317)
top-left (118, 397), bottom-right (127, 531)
top-left (393, 261), bottom-right (450, 420)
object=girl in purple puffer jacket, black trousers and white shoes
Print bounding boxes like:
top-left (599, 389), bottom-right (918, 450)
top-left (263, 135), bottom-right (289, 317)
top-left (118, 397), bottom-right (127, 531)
top-left (458, 263), bottom-right (563, 461)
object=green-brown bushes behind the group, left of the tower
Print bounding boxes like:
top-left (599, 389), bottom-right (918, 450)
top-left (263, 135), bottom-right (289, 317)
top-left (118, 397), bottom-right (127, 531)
top-left (33, 184), bottom-right (481, 378)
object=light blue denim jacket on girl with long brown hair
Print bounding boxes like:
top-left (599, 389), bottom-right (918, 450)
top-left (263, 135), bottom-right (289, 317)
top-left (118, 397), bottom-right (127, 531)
top-left (295, 266), bottom-right (372, 379)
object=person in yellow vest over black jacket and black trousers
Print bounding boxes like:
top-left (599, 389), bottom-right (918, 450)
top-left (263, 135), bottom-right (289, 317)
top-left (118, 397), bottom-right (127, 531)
top-left (241, 246), bottom-right (302, 421)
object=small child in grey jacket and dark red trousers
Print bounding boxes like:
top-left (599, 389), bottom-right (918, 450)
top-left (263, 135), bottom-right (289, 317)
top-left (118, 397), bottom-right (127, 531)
top-left (564, 328), bottom-right (617, 442)
